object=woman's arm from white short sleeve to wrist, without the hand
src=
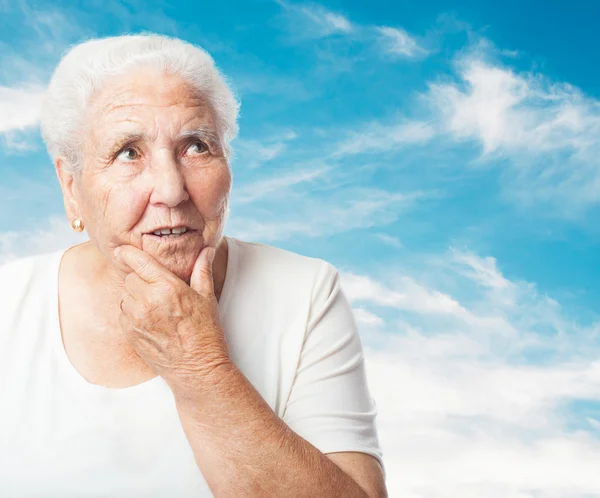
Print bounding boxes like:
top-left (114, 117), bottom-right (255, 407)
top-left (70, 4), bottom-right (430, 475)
top-left (176, 264), bottom-right (387, 497)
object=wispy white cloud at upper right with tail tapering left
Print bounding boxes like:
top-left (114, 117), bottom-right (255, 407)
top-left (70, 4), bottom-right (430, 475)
top-left (330, 37), bottom-right (600, 220)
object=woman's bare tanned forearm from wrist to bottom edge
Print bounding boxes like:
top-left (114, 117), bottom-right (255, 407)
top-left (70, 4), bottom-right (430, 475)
top-left (174, 362), bottom-right (368, 498)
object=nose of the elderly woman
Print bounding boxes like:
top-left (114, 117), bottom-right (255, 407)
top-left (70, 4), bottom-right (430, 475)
top-left (150, 151), bottom-right (190, 207)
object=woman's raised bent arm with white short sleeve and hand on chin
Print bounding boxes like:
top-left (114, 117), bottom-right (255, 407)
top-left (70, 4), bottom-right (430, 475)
top-left (115, 246), bottom-right (381, 498)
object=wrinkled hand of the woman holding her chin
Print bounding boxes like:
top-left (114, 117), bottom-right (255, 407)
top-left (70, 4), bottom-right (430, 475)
top-left (115, 245), bottom-right (229, 392)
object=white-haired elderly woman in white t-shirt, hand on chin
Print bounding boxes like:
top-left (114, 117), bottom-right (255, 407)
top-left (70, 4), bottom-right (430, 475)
top-left (0, 35), bottom-right (386, 498)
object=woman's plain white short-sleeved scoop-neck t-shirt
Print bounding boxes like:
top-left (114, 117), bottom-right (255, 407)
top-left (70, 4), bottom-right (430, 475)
top-left (0, 237), bottom-right (383, 498)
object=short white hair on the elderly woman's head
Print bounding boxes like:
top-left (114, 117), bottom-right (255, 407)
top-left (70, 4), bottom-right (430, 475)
top-left (40, 33), bottom-right (239, 175)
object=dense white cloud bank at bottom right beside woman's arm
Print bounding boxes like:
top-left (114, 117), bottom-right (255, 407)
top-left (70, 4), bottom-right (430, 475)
top-left (365, 336), bottom-right (600, 498)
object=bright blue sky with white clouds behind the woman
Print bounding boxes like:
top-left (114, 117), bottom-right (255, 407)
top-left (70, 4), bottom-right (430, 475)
top-left (0, 0), bottom-right (600, 498)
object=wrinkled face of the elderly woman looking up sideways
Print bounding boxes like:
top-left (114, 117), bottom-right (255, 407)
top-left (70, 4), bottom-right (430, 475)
top-left (63, 68), bottom-right (232, 281)
